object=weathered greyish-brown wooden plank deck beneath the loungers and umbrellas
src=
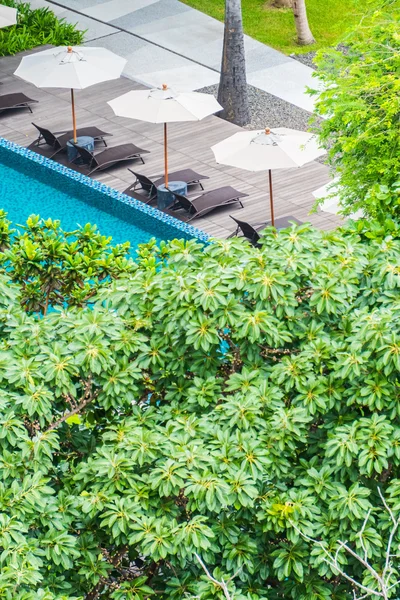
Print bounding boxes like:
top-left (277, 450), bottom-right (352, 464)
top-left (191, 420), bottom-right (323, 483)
top-left (0, 47), bottom-right (341, 237)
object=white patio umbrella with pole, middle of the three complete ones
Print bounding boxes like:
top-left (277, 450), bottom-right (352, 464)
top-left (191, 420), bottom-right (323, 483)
top-left (108, 83), bottom-right (222, 187)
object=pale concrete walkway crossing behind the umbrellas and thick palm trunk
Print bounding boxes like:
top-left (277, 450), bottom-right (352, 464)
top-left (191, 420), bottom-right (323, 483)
top-left (32, 0), bottom-right (316, 112)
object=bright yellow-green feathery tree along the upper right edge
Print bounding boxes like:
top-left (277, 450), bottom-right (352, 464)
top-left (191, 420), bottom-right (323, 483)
top-left (316, 0), bottom-right (400, 222)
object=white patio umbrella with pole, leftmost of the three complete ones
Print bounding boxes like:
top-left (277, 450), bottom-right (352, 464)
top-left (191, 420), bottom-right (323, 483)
top-left (14, 46), bottom-right (126, 142)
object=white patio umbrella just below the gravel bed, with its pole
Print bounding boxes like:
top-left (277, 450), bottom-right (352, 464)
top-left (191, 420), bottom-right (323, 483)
top-left (211, 127), bottom-right (325, 225)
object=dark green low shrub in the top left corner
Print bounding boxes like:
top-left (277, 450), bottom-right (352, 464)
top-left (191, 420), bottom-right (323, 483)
top-left (0, 0), bottom-right (84, 56)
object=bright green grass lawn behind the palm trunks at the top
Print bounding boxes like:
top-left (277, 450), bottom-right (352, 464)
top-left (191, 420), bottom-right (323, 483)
top-left (182, 0), bottom-right (366, 54)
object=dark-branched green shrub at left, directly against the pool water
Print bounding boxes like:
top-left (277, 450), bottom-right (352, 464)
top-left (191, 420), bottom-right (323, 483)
top-left (0, 211), bottom-right (136, 314)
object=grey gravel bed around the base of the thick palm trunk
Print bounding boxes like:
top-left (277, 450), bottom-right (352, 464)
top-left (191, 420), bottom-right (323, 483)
top-left (197, 85), bottom-right (318, 131)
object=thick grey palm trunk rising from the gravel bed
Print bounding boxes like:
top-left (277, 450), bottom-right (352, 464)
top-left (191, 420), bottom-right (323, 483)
top-left (218, 0), bottom-right (250, 125)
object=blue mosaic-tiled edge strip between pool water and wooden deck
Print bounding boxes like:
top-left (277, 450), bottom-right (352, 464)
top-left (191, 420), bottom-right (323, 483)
top-left (0, 137), bottom-right (210, 243)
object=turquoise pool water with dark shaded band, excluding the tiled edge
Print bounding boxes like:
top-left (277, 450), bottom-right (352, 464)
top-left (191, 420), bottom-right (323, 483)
top-left (0, 147), bottom-right (195, 250)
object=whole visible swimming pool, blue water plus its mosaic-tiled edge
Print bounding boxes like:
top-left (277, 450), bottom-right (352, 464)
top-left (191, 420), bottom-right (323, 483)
top-left (0, 138), bottom-right (208, 248)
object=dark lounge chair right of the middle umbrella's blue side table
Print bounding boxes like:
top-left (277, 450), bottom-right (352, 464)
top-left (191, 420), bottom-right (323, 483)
top-left (168, 185), bottom-right (248, 221)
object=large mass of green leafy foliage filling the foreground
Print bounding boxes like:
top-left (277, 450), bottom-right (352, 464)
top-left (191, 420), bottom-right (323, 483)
top-left (0, 217), bottom-right (400, 600)
